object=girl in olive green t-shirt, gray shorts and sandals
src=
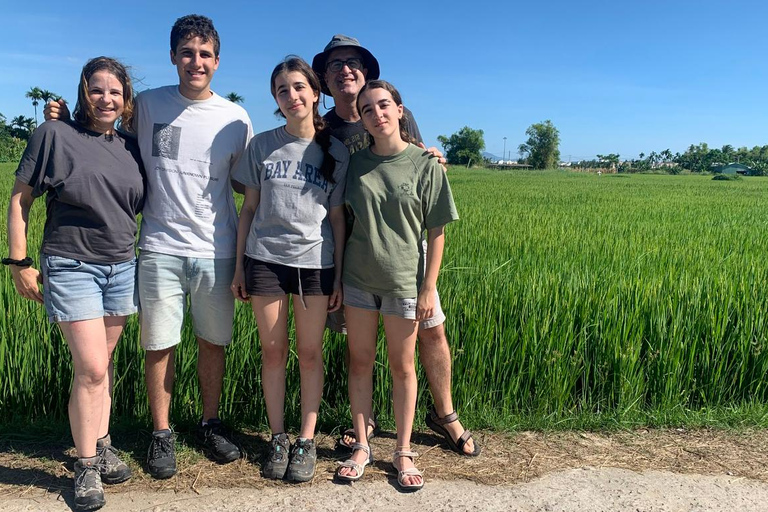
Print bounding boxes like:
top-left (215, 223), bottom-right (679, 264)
top-left (336, 80), bottom-right (458, 490)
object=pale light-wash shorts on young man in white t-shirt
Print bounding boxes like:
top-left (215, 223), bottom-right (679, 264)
top-left (139, 251), bottom-right (235, 350)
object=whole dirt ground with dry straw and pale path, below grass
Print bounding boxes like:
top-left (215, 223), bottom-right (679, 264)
top-left (0, 430), bottom-right (768, 512)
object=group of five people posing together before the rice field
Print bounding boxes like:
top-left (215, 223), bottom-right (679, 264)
top-left (3, 15), bottom-right (480, 510)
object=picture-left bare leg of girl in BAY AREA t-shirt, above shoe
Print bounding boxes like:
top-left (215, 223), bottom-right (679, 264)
top-left (251, 295), bottom-right (290, 434)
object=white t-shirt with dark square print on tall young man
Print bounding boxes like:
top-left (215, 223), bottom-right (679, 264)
top-left (135, 85), bottom-right (253, 258)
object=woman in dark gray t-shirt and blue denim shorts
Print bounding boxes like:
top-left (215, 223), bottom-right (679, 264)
top-left (3, 57), bottom-right (144, 510)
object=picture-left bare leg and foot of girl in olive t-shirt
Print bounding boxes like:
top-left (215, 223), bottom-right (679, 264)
top-left (339, 306), bottom-right (379, 476)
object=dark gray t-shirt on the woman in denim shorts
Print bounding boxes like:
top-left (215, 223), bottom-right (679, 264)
top-left (16, 121), bottom-right (145, 263)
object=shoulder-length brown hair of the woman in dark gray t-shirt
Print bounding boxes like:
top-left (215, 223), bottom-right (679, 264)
top-left (74, 57), bottom-right (133, 132)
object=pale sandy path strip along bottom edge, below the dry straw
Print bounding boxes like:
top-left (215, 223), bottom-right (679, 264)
top-left (0, 468), bottom-right (768, 512)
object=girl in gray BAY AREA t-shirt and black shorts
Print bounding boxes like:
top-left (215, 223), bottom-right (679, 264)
top-left (232, 57), bottom-right (349, 482)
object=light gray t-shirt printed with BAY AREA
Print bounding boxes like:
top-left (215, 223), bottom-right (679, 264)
top-left (232, 126), bottom-right (349, 269)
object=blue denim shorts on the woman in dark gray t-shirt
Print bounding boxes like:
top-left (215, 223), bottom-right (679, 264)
top-left (40, 254), bottom-right (139, 322)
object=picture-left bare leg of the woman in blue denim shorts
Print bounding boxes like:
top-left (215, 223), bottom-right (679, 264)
top-left (59, 317), bottom-right (125, 458)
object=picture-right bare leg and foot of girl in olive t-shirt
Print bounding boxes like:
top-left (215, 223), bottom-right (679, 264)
top-left (384, 315), bottom-right (423, 485)
